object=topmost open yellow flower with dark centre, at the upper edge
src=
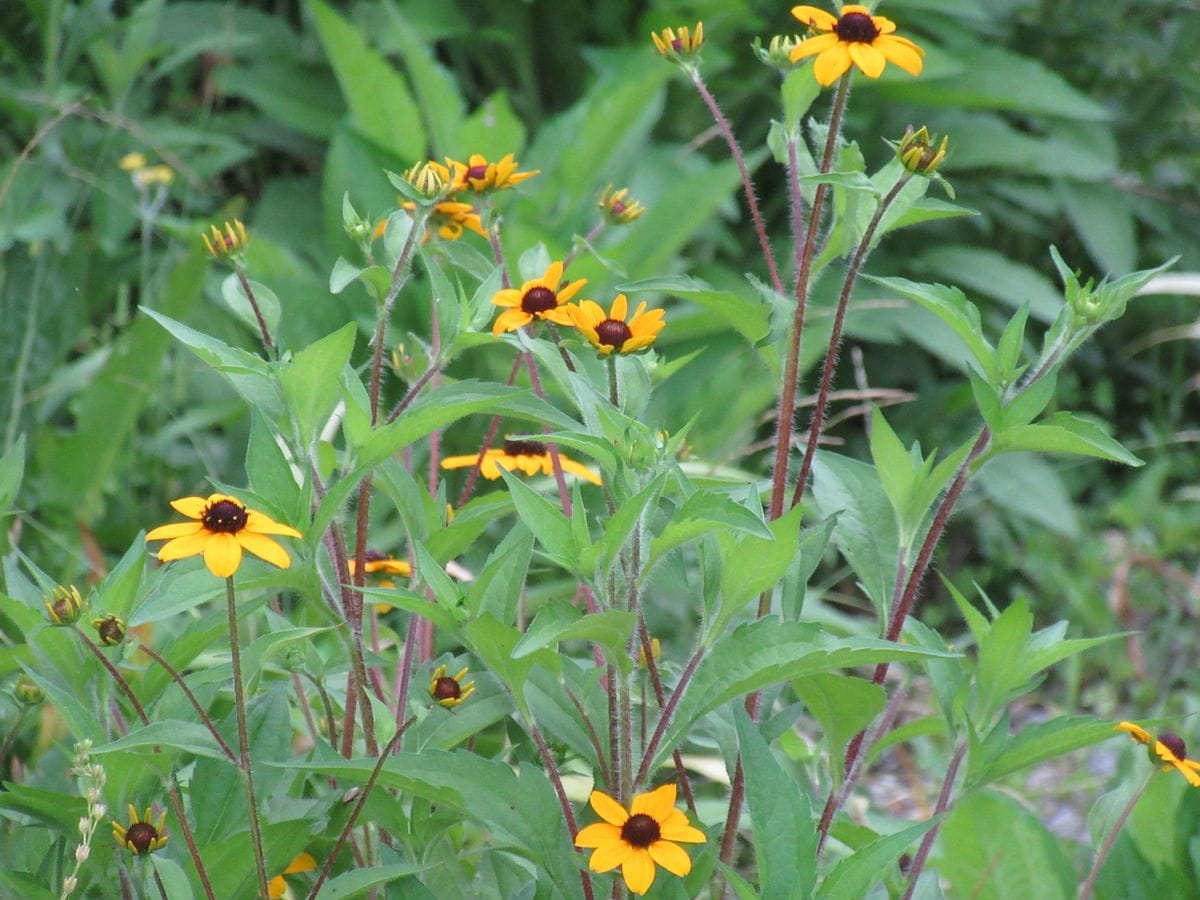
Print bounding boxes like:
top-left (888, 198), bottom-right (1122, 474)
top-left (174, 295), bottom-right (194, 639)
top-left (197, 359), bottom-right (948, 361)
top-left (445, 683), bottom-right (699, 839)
top-left (791, 4), bottom-right (925, 88)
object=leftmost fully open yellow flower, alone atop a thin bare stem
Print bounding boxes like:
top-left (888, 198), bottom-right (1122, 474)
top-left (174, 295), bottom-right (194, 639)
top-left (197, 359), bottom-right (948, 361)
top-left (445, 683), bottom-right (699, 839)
top-left (146, 493), bottom-right (302, 578)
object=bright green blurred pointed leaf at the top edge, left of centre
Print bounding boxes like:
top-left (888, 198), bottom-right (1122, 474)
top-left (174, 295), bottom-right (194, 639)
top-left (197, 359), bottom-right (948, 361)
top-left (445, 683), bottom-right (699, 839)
top-left (307, 0), bottom-right (426, 161)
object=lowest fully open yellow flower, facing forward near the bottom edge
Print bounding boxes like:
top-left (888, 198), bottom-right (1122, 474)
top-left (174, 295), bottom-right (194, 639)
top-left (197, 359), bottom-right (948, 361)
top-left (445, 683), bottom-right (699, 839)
top-left (575, 784), bottom-right (708, 894)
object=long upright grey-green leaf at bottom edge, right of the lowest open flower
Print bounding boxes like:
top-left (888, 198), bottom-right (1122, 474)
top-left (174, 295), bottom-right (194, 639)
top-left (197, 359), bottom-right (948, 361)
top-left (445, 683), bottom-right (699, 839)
top-left (733, 708), bottom-right (816, 900)
